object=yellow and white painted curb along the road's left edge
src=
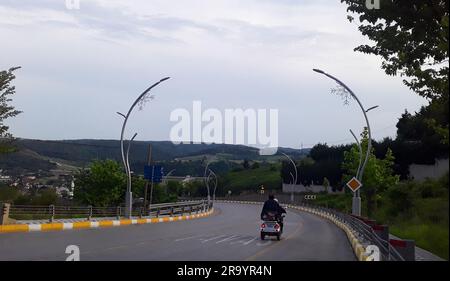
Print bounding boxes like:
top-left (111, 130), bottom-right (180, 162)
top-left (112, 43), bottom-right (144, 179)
top-left (0, 208), bottom-right (214, 233)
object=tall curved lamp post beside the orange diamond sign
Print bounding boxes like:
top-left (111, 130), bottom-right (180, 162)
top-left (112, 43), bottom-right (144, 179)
top-left (313, 69), bottom-right (376, 216)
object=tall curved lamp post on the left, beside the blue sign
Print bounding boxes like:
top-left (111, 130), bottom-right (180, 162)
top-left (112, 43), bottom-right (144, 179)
top-left (119, 77), bottom-right (170, 218)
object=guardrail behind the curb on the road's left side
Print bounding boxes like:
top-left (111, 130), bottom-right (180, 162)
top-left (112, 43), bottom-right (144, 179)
top-left (0, 200), bottom-right (212, 223)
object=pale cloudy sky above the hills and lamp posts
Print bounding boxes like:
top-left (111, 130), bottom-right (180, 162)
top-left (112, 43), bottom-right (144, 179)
top-left (0, 0), bottom-right (426, 148)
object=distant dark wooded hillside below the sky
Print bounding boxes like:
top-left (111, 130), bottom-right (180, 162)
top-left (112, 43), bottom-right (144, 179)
top-left (0, 139), bottom-right (309, 175)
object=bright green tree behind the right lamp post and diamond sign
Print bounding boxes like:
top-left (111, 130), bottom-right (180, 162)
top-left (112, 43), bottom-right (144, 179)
top-left (342, 129), bottom-right (399, 217)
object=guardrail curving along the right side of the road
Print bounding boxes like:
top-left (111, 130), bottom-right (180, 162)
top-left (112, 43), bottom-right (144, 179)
top-left (218, 198), bottom-right (415, 261)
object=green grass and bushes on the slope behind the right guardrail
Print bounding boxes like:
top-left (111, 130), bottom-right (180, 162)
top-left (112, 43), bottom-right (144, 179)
top-left (314, 174), bottom-right (449, 260)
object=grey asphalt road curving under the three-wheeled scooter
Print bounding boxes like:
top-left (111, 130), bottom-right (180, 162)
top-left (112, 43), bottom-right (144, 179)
top-left (0, 203), bottom-right (355, 261)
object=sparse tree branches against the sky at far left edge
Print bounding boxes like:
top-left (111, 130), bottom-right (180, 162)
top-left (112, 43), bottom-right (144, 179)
top-left (0, 67), bottom-right (21, 153)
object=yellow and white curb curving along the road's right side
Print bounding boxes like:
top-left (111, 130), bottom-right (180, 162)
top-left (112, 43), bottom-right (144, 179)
top-left (217, 200), bottom-right (367, 261)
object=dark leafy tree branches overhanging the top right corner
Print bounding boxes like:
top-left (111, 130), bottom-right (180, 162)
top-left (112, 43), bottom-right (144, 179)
top-left (341, 0), bottom-right (449, 144)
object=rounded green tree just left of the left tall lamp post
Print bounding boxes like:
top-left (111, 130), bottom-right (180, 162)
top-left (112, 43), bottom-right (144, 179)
top-left (74, 160), bottom-right (126, 207)
